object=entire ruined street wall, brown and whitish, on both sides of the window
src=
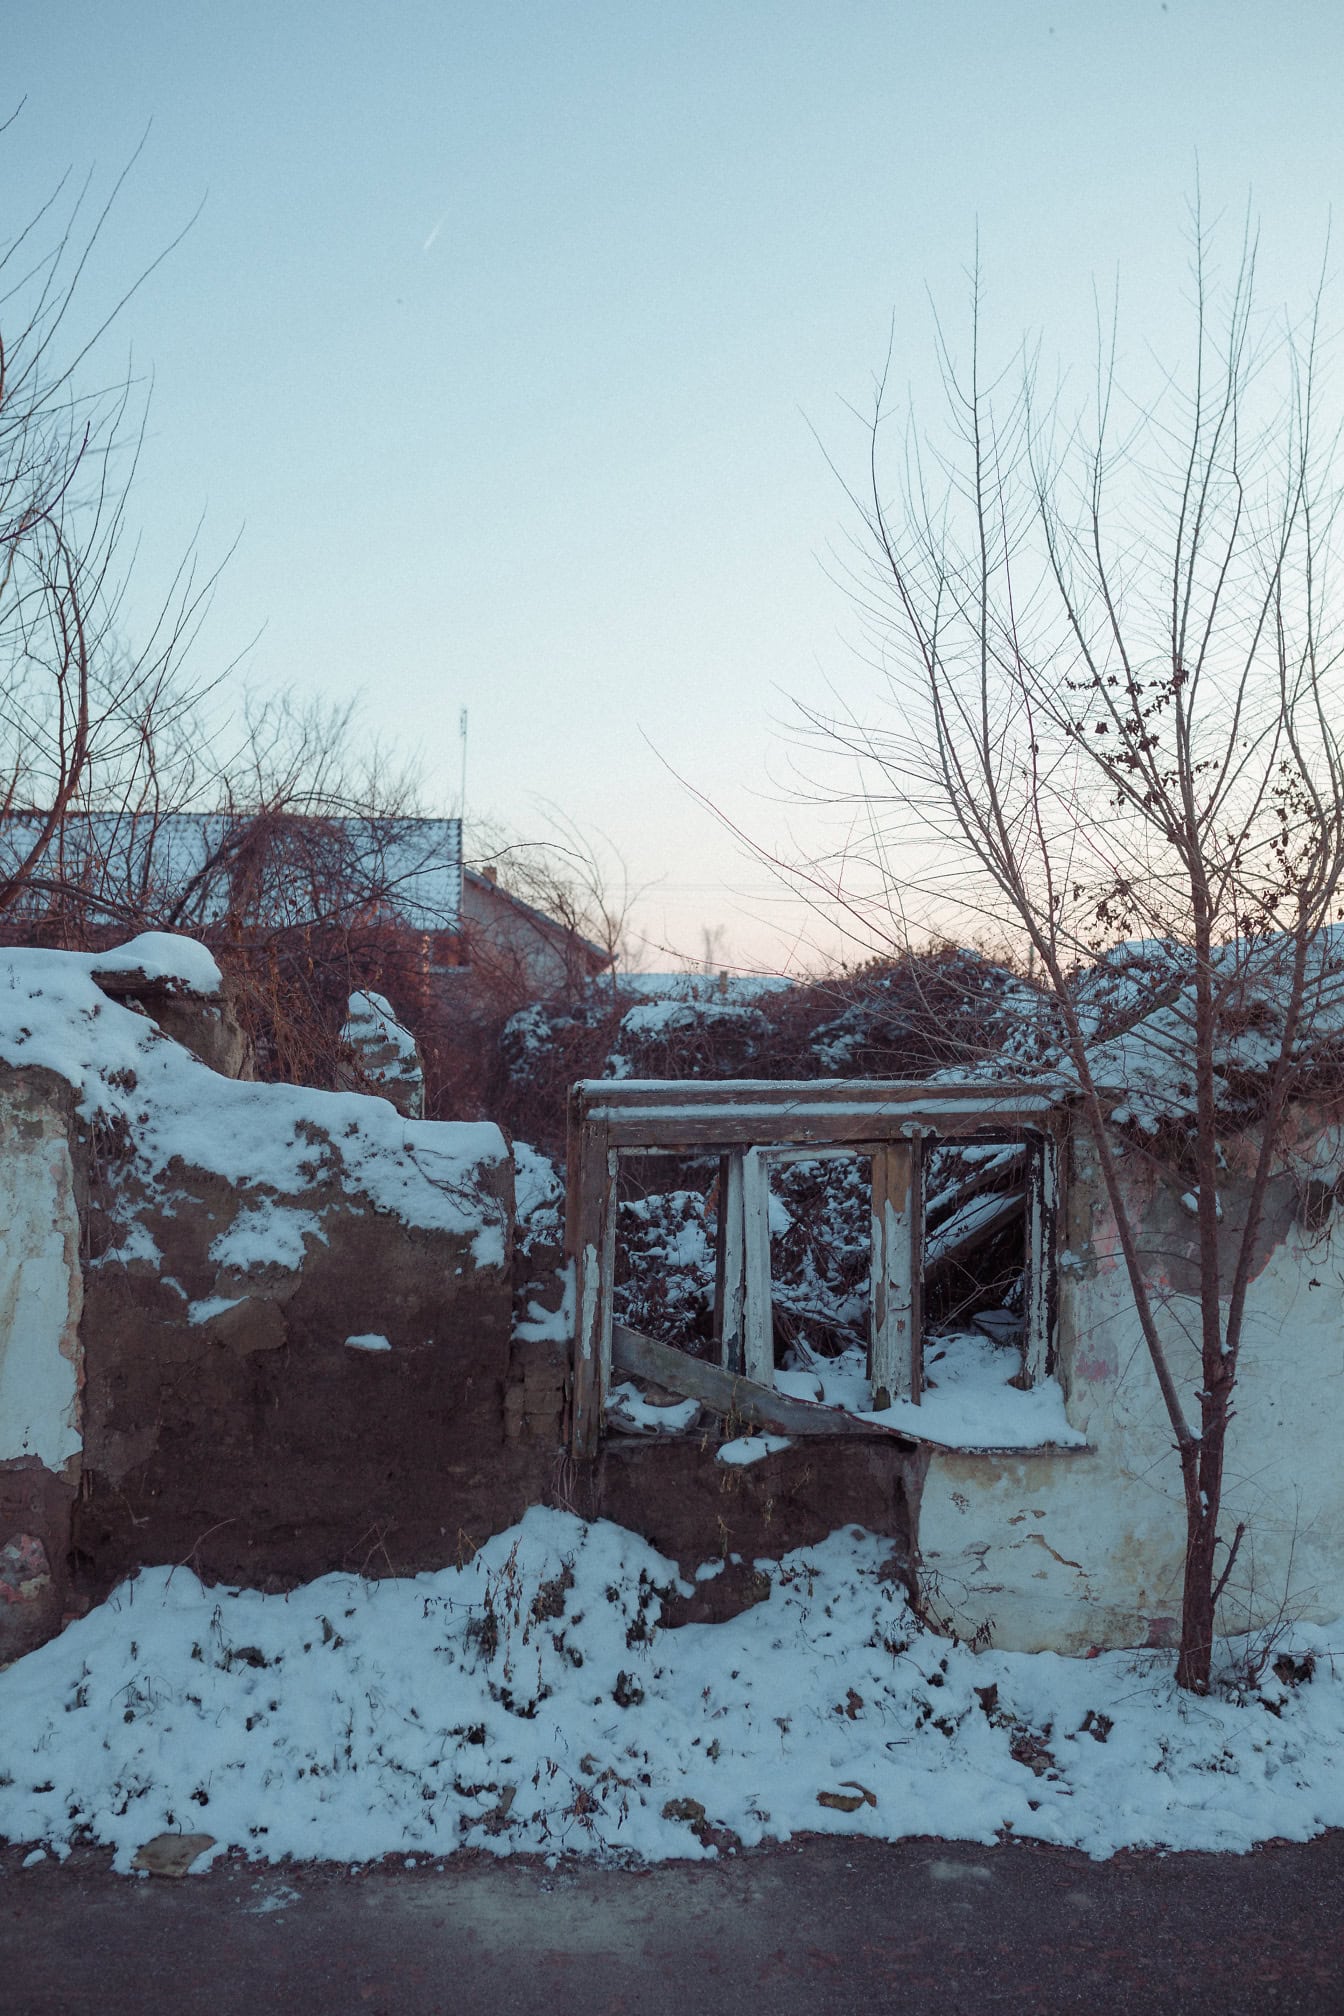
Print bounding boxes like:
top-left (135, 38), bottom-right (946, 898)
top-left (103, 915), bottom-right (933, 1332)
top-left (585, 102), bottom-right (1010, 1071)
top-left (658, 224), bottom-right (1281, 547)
top-left (15, 941), bottom-right (1344, 1659)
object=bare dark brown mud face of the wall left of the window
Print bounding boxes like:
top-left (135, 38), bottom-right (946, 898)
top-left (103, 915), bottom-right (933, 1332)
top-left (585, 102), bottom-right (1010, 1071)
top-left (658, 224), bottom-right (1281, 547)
top-left (75, 1163), bottom-right (530, 1587)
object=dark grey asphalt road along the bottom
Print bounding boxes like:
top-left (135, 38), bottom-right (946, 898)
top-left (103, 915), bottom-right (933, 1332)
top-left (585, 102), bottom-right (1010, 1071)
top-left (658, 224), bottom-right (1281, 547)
top-left (0, 1833), bottom-right (1344, 2016)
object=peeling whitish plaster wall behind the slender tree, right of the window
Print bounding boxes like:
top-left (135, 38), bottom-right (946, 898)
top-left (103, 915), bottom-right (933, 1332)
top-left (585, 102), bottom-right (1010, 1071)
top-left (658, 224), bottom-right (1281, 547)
top-left (919, 1109), bottom-right (1344, 1651)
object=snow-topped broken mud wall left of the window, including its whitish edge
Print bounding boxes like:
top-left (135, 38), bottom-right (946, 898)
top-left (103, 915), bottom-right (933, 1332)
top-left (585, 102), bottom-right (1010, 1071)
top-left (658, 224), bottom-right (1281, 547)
top-left (0, 937), bottom-right (558, 1657)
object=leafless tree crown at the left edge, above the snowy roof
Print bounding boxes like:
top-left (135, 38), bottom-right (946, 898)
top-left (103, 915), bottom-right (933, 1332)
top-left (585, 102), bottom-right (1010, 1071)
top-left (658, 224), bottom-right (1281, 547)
top-left (0, 115), bottom-right (214, 911)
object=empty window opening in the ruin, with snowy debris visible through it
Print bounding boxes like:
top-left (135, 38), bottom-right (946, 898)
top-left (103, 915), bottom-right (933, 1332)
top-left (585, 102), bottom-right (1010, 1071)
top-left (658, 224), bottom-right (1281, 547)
top-left (566, 1083), bottom-right (1058, 1454)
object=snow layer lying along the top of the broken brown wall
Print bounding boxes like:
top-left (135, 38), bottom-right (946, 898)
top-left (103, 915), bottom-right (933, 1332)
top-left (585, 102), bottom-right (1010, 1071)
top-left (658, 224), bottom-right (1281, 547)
top-left (0, 933), bottom-right (508, 1266)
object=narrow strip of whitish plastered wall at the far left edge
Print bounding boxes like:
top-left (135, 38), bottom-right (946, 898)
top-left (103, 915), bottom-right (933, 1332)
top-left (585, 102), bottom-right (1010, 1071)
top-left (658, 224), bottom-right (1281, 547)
top-left (0, 1070), bottom-right (83, 1661)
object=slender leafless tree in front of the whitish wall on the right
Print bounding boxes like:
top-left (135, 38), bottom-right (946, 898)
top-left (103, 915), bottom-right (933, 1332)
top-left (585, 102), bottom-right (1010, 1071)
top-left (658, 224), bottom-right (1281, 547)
top-left (808, 212), bottom-right (1344, 1691)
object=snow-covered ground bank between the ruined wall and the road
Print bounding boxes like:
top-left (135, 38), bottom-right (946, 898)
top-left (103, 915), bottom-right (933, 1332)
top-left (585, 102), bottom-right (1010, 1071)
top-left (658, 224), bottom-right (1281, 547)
top-left (0, 1508), bottom-right (1344, 1869)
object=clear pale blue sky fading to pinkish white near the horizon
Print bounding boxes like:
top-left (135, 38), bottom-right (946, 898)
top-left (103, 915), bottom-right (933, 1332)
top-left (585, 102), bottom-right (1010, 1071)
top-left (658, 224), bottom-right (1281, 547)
top-left (0, 0), bottom-right (1344, 964)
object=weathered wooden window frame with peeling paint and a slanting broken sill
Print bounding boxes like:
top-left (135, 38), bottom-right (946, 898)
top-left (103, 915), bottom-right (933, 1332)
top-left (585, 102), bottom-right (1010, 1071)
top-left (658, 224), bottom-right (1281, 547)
top-left (564, 1079), bottom-right (1064, 1458)
